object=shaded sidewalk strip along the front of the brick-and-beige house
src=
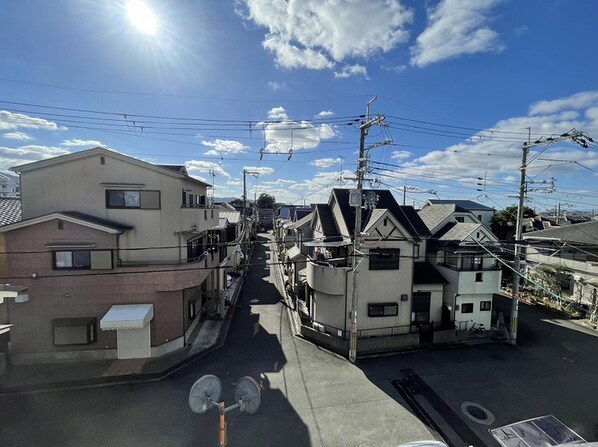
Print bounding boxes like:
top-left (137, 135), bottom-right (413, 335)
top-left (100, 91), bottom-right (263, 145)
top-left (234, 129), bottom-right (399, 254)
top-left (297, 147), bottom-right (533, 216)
top-left (0, 281), bottom-right (243, 394)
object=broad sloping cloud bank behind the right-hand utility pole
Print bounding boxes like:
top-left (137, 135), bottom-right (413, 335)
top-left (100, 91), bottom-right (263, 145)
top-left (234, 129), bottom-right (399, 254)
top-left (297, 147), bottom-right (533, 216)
top-left (386, 92), bottom-right (598, 189)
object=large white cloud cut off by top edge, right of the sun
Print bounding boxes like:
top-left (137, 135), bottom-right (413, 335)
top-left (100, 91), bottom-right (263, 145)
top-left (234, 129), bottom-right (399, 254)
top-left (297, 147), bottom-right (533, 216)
top-left (237, 0), bottom-right (413, 70)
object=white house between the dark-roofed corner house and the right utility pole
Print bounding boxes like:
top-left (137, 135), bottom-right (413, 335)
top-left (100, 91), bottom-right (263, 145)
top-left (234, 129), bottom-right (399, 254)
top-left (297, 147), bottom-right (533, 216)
top-left (418, 204), bottom-right (501, 330)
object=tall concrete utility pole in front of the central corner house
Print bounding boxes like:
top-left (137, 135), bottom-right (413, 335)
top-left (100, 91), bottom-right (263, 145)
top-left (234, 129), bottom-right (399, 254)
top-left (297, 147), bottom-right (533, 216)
top-left (349, 96), bottom-right (384, 363)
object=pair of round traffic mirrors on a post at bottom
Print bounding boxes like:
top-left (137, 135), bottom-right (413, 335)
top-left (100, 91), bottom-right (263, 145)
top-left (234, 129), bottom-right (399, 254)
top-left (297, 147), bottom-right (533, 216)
top-left (189, 374), bottom-right (262, 447)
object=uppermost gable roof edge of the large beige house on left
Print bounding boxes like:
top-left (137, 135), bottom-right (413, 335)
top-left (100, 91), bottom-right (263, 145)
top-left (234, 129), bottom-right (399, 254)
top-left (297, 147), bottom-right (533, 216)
top-left (10, 147), bottom-right (211, 186)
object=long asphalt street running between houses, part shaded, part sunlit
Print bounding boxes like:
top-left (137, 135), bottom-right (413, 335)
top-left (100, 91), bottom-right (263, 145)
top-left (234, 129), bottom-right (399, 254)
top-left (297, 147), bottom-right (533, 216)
top-left (0, 239), bottom-right (432, 447)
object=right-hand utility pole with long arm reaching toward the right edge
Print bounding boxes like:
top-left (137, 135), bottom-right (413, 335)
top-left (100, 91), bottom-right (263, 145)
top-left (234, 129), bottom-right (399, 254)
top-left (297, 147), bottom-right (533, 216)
top-left (509, 127), bottom-right (594, 346)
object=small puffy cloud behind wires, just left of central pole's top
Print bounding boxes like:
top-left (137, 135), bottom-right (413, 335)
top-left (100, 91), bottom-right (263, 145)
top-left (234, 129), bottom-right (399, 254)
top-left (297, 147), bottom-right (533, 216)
top-left (258, 107), bottom-right (336, 154)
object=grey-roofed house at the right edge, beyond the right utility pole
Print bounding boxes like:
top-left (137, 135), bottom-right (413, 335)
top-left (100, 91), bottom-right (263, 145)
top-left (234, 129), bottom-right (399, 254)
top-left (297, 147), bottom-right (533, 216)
top-left (523, 220), bottom-right (598, 319)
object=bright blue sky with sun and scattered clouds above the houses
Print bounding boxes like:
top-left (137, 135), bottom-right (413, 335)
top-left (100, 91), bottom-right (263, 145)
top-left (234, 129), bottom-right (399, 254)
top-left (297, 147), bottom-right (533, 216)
top-left (0, 0), bottom-right (598, 212)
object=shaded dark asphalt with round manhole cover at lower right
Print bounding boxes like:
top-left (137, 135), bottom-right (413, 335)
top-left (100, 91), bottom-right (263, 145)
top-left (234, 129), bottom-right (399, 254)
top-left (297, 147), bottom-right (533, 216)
top-left (360, 300), bottom-right (598, 446)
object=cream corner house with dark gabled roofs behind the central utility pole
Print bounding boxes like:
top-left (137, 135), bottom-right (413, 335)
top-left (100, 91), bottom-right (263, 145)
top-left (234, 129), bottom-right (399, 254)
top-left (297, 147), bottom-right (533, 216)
top-left (294, 189), bottom-right (454, 353)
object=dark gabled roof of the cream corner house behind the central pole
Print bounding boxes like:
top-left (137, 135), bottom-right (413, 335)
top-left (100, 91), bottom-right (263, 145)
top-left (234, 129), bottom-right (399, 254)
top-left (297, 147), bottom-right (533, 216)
top-left (328, 188), bottom-right (430, 239)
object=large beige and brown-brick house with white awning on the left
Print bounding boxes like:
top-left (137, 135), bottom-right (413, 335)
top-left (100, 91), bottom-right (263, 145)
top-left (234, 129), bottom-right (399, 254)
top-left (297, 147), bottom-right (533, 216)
top-left (0, 148), bottom-right (226, 363)
